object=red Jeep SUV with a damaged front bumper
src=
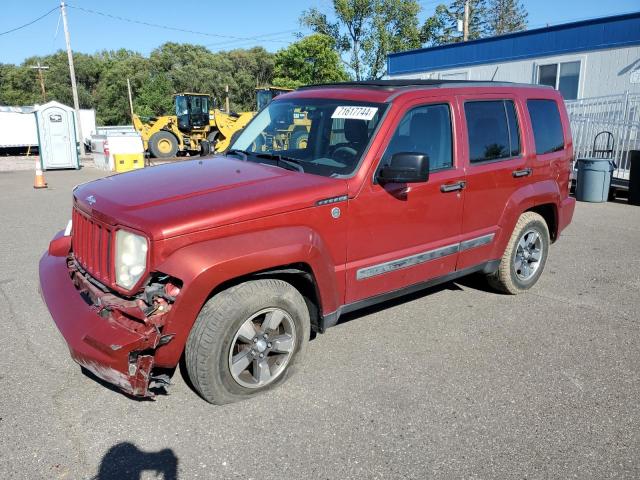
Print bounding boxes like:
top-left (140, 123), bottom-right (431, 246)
top-left (40, 80), bottom-right (575, 404)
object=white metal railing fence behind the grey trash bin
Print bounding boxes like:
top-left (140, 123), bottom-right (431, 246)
top-left (565, 93), bottom-right (640, 180)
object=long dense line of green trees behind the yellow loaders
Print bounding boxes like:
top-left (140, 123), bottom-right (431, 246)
top-left (0, 43), bottom-right (275, 125)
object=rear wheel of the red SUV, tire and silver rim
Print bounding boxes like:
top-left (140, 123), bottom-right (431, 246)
top-left (487, 212), bottom-right (551, 295)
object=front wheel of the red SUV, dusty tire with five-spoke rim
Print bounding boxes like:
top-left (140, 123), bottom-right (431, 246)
top-left (185, 279), bottom-right (310, 405)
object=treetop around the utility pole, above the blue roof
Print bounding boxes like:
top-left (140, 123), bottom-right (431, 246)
top-left (421, 0), bottom-right (489, 45)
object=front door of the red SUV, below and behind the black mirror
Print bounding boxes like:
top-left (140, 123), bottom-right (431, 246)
top-left (345, 99), bottom-right (465, 304)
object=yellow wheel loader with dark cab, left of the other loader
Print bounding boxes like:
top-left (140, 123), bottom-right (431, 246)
top-left (133, 93), bottom-right (254, 158)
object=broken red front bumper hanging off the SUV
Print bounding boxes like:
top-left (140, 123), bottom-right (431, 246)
top-left (40, 234), bottom-right (171, 397)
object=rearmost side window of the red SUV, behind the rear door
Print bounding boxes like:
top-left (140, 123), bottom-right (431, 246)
top-left (527, 100), bottom-right (564, 155)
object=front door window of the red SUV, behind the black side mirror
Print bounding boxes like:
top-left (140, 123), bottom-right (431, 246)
top-left (382, 104), bottom-right (453, 171)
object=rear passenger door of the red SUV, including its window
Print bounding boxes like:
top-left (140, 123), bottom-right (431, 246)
top-left (457, 94), bottom-right (532, 270)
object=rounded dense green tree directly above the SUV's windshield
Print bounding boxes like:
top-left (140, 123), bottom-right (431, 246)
top-left (273, 33), bottom-right (349, 88)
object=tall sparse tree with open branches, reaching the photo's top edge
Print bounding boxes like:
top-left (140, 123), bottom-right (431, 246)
top-left (300, 0), bottom-right (420, 80)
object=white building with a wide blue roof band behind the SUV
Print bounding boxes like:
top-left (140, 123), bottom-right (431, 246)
top-left (387, 12), bottom-right (640, 100)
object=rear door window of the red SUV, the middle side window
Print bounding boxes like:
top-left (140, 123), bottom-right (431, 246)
top-left (464, 100), bottom-right (520, 163)
